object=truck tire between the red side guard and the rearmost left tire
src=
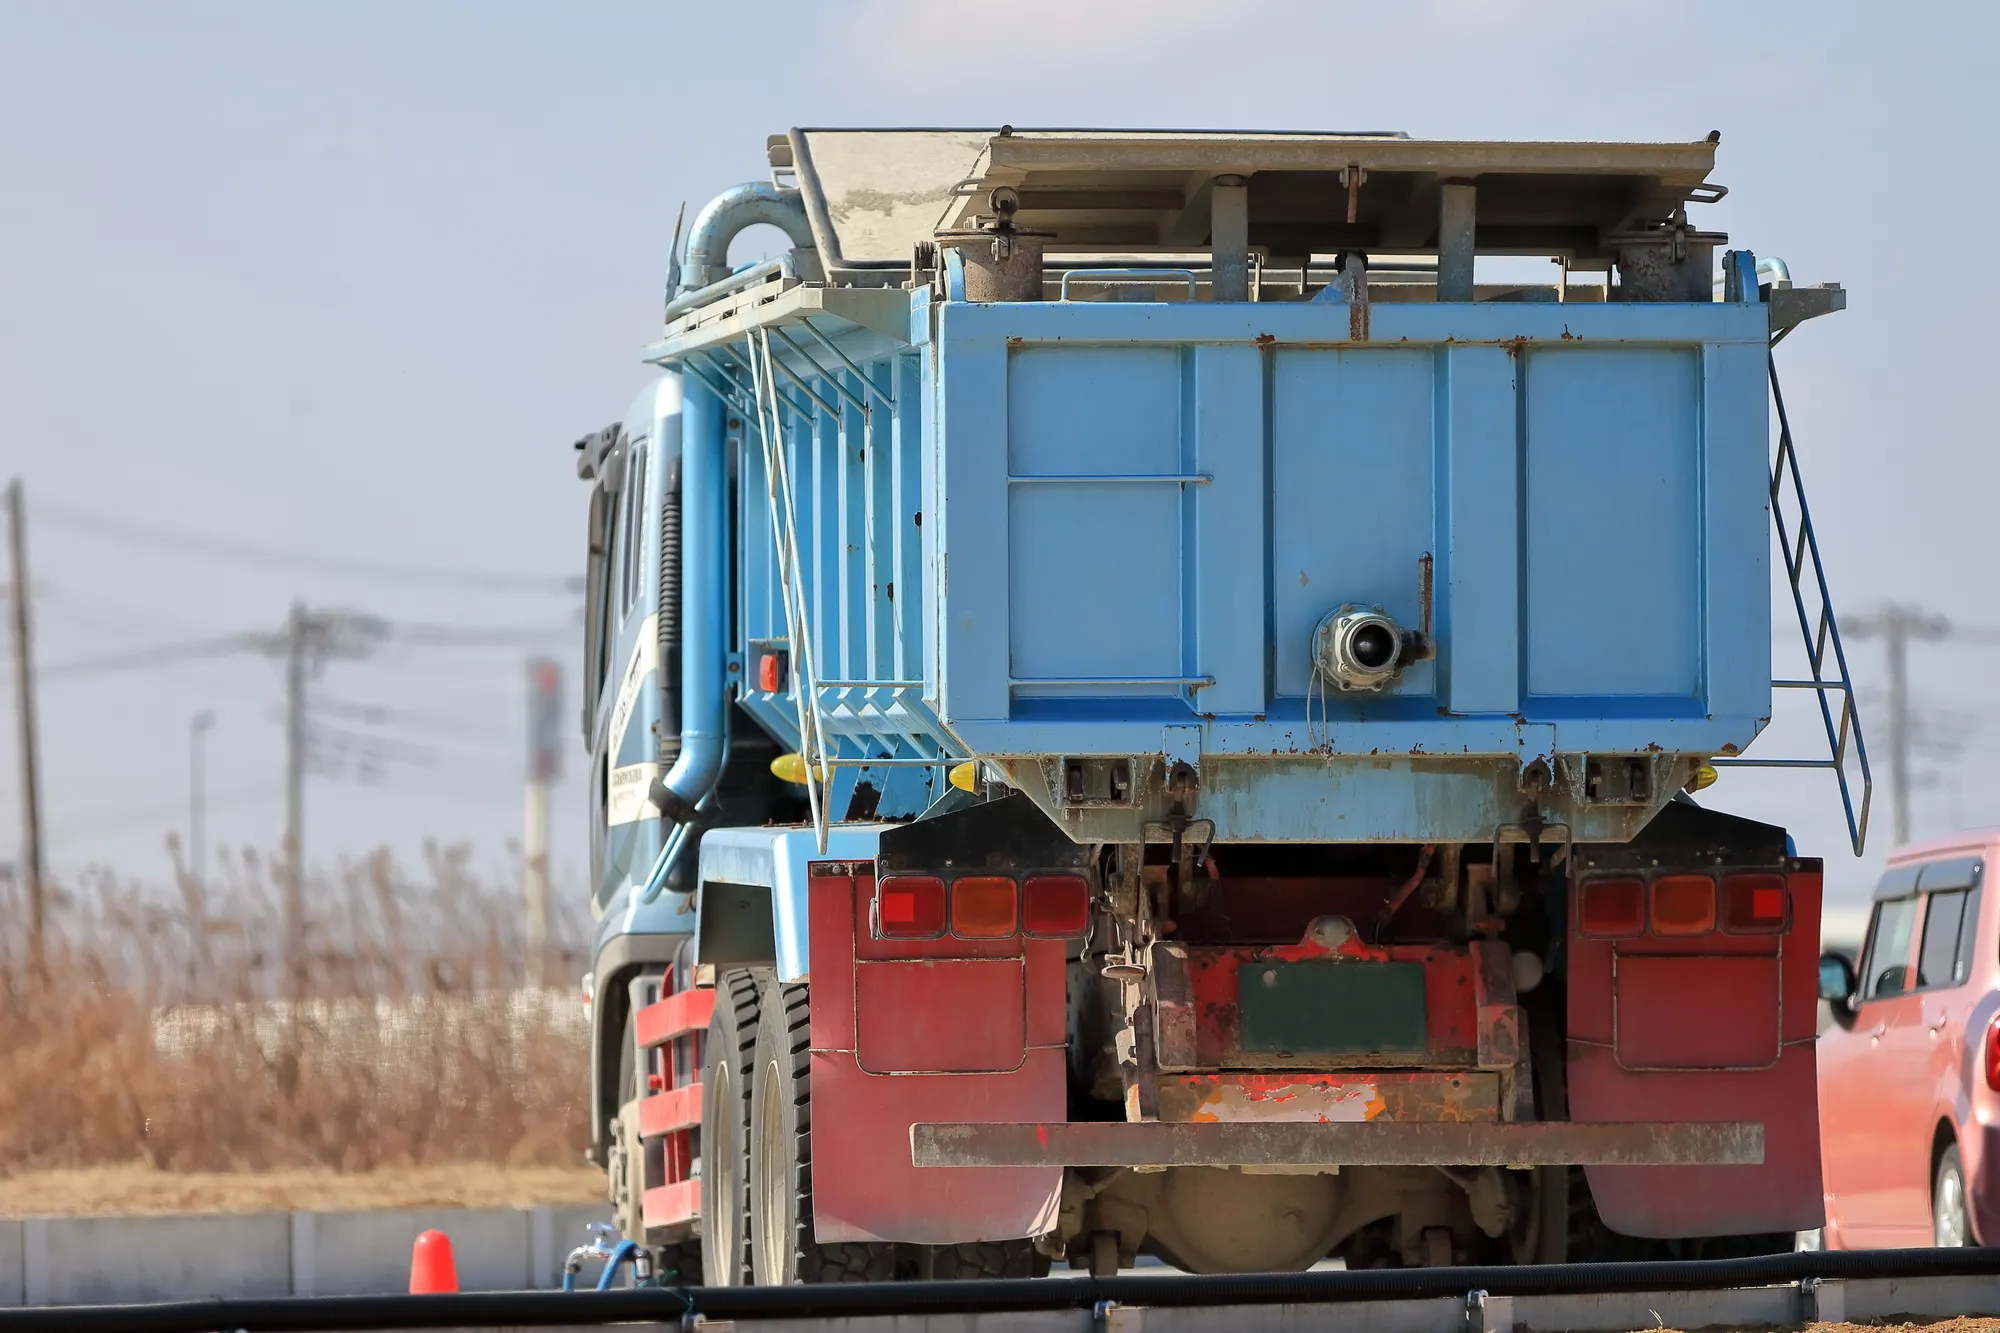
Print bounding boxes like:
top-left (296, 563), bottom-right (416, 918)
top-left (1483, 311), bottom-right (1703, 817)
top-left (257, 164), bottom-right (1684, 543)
top-left (702, 969), bottom-right (762, 1287)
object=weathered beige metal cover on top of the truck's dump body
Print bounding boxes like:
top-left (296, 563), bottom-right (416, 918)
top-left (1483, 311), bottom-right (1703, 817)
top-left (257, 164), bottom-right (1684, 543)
top-left (772, 130), bottom-right (1722, 268)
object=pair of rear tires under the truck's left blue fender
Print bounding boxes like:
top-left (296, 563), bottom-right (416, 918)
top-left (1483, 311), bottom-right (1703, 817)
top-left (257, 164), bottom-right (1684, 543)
top-left (702, 971), bottom-right (1048, 1287)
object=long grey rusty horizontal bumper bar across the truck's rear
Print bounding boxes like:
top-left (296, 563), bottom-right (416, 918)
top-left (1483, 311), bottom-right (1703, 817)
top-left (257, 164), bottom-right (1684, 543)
top-left (910, 1121), bottom-right (1764, 1167)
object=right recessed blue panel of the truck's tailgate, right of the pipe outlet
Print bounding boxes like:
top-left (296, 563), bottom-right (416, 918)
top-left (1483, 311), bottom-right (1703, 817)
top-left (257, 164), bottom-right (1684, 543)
top-left (1522, 348), bottom-right (1696, 699)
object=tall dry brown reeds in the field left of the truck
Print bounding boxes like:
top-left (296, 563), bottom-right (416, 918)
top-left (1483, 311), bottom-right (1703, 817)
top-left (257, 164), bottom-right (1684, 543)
top-left (0, 849), bottom-right (588, 1173)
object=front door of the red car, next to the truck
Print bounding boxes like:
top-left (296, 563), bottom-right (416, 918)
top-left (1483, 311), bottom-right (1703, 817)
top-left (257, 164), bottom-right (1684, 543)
top-left (1820, 867), bottom-right (1930, 1249)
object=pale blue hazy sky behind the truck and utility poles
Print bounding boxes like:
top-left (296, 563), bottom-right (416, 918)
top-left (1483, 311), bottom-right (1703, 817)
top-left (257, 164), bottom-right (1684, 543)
top-left (0, 0), bottom-right (2000, 920)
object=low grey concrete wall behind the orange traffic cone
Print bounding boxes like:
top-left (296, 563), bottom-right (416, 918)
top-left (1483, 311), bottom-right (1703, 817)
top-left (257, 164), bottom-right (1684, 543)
top-left (0, 1207), bottom-right (610, 1307)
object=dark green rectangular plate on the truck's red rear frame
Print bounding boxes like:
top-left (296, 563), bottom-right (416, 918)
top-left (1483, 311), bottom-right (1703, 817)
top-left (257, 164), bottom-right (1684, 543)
top-left (1236, 959), bottom-right (1428, 1055)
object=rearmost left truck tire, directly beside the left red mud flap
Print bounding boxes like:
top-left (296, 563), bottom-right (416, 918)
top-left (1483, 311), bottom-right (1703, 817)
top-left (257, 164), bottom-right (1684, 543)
top-left (750, 981), bottom-right (896, 1287)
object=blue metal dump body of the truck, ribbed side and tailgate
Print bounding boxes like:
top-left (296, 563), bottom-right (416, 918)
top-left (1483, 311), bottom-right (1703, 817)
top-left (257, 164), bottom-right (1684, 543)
top-left (632, 260), bottom-right (1772, 841)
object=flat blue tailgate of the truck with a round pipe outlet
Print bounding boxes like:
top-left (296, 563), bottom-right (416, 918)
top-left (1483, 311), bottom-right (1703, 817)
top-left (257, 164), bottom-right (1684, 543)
top-left (934, 302), bottom-right (1768, 772)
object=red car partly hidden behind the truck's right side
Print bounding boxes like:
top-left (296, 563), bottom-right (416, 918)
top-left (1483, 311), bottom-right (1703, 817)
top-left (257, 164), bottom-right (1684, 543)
top-left (1806, 831), bottom-right (2000, 1249)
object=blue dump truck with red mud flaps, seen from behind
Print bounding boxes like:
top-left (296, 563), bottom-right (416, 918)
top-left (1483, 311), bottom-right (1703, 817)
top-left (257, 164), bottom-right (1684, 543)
top-left (578, 128), bottom-right (1866, 1283)
